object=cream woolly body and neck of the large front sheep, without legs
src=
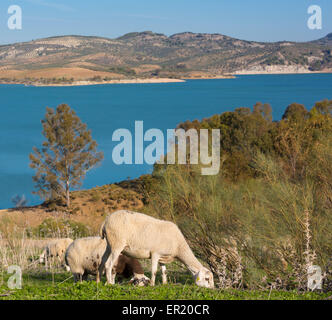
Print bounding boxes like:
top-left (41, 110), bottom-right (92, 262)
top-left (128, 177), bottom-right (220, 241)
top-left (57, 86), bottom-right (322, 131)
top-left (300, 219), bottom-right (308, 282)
top-left (101, 210), bottom-right (203, 274)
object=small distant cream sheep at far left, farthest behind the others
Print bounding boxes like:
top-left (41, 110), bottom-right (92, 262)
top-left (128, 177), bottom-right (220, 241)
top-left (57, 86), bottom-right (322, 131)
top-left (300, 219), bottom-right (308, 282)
top-left (39, 238), bottom-right (73, 271)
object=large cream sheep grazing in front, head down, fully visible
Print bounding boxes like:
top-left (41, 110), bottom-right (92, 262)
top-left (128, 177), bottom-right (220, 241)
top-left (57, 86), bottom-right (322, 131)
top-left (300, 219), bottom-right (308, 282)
top-left (100, 210), bottom-right (214, 288)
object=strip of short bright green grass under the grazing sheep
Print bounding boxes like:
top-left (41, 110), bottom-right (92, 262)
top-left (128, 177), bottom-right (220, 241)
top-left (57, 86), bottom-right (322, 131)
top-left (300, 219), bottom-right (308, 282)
top-left (0, 271), bottom-right (331, 300)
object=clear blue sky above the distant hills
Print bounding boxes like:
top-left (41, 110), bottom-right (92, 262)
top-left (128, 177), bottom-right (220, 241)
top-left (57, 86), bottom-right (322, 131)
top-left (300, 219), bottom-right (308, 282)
top-left (0, 0), bottom-right (332, 44)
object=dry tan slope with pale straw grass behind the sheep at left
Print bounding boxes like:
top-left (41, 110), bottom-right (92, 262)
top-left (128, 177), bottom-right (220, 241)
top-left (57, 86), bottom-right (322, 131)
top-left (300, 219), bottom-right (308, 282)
top-left (0, 185), bottom-right (143, 278)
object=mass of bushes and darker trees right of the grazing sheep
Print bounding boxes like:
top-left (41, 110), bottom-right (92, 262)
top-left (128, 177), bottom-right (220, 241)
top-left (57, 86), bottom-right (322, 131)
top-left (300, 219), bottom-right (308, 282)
top-left (145, 100), bottom-right (332, 290)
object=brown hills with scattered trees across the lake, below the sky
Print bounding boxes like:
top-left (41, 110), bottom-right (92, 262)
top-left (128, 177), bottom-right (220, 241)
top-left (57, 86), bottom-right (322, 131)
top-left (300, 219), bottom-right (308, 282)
top-left (0, 31), bottom-right (332, 84)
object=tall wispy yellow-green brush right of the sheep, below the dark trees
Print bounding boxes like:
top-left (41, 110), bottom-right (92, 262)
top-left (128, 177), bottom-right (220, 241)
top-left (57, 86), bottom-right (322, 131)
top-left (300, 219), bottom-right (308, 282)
top-left (146, 137), bottom-right (332, 290)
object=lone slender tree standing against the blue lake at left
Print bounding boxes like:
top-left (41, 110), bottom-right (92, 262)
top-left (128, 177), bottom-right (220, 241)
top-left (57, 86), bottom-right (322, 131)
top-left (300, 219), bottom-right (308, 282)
top-left (30, 104), bottom-right (103, 208)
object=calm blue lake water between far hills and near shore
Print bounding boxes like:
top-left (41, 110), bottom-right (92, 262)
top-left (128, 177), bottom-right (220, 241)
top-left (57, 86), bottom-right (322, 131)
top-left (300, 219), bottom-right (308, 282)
top-left (0, 74), bottom-right (332, 209)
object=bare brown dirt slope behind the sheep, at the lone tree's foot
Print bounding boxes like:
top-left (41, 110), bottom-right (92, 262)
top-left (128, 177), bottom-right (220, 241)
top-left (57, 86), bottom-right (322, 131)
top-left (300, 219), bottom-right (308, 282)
top-left (0, 185), bottom-right (144, 234)
